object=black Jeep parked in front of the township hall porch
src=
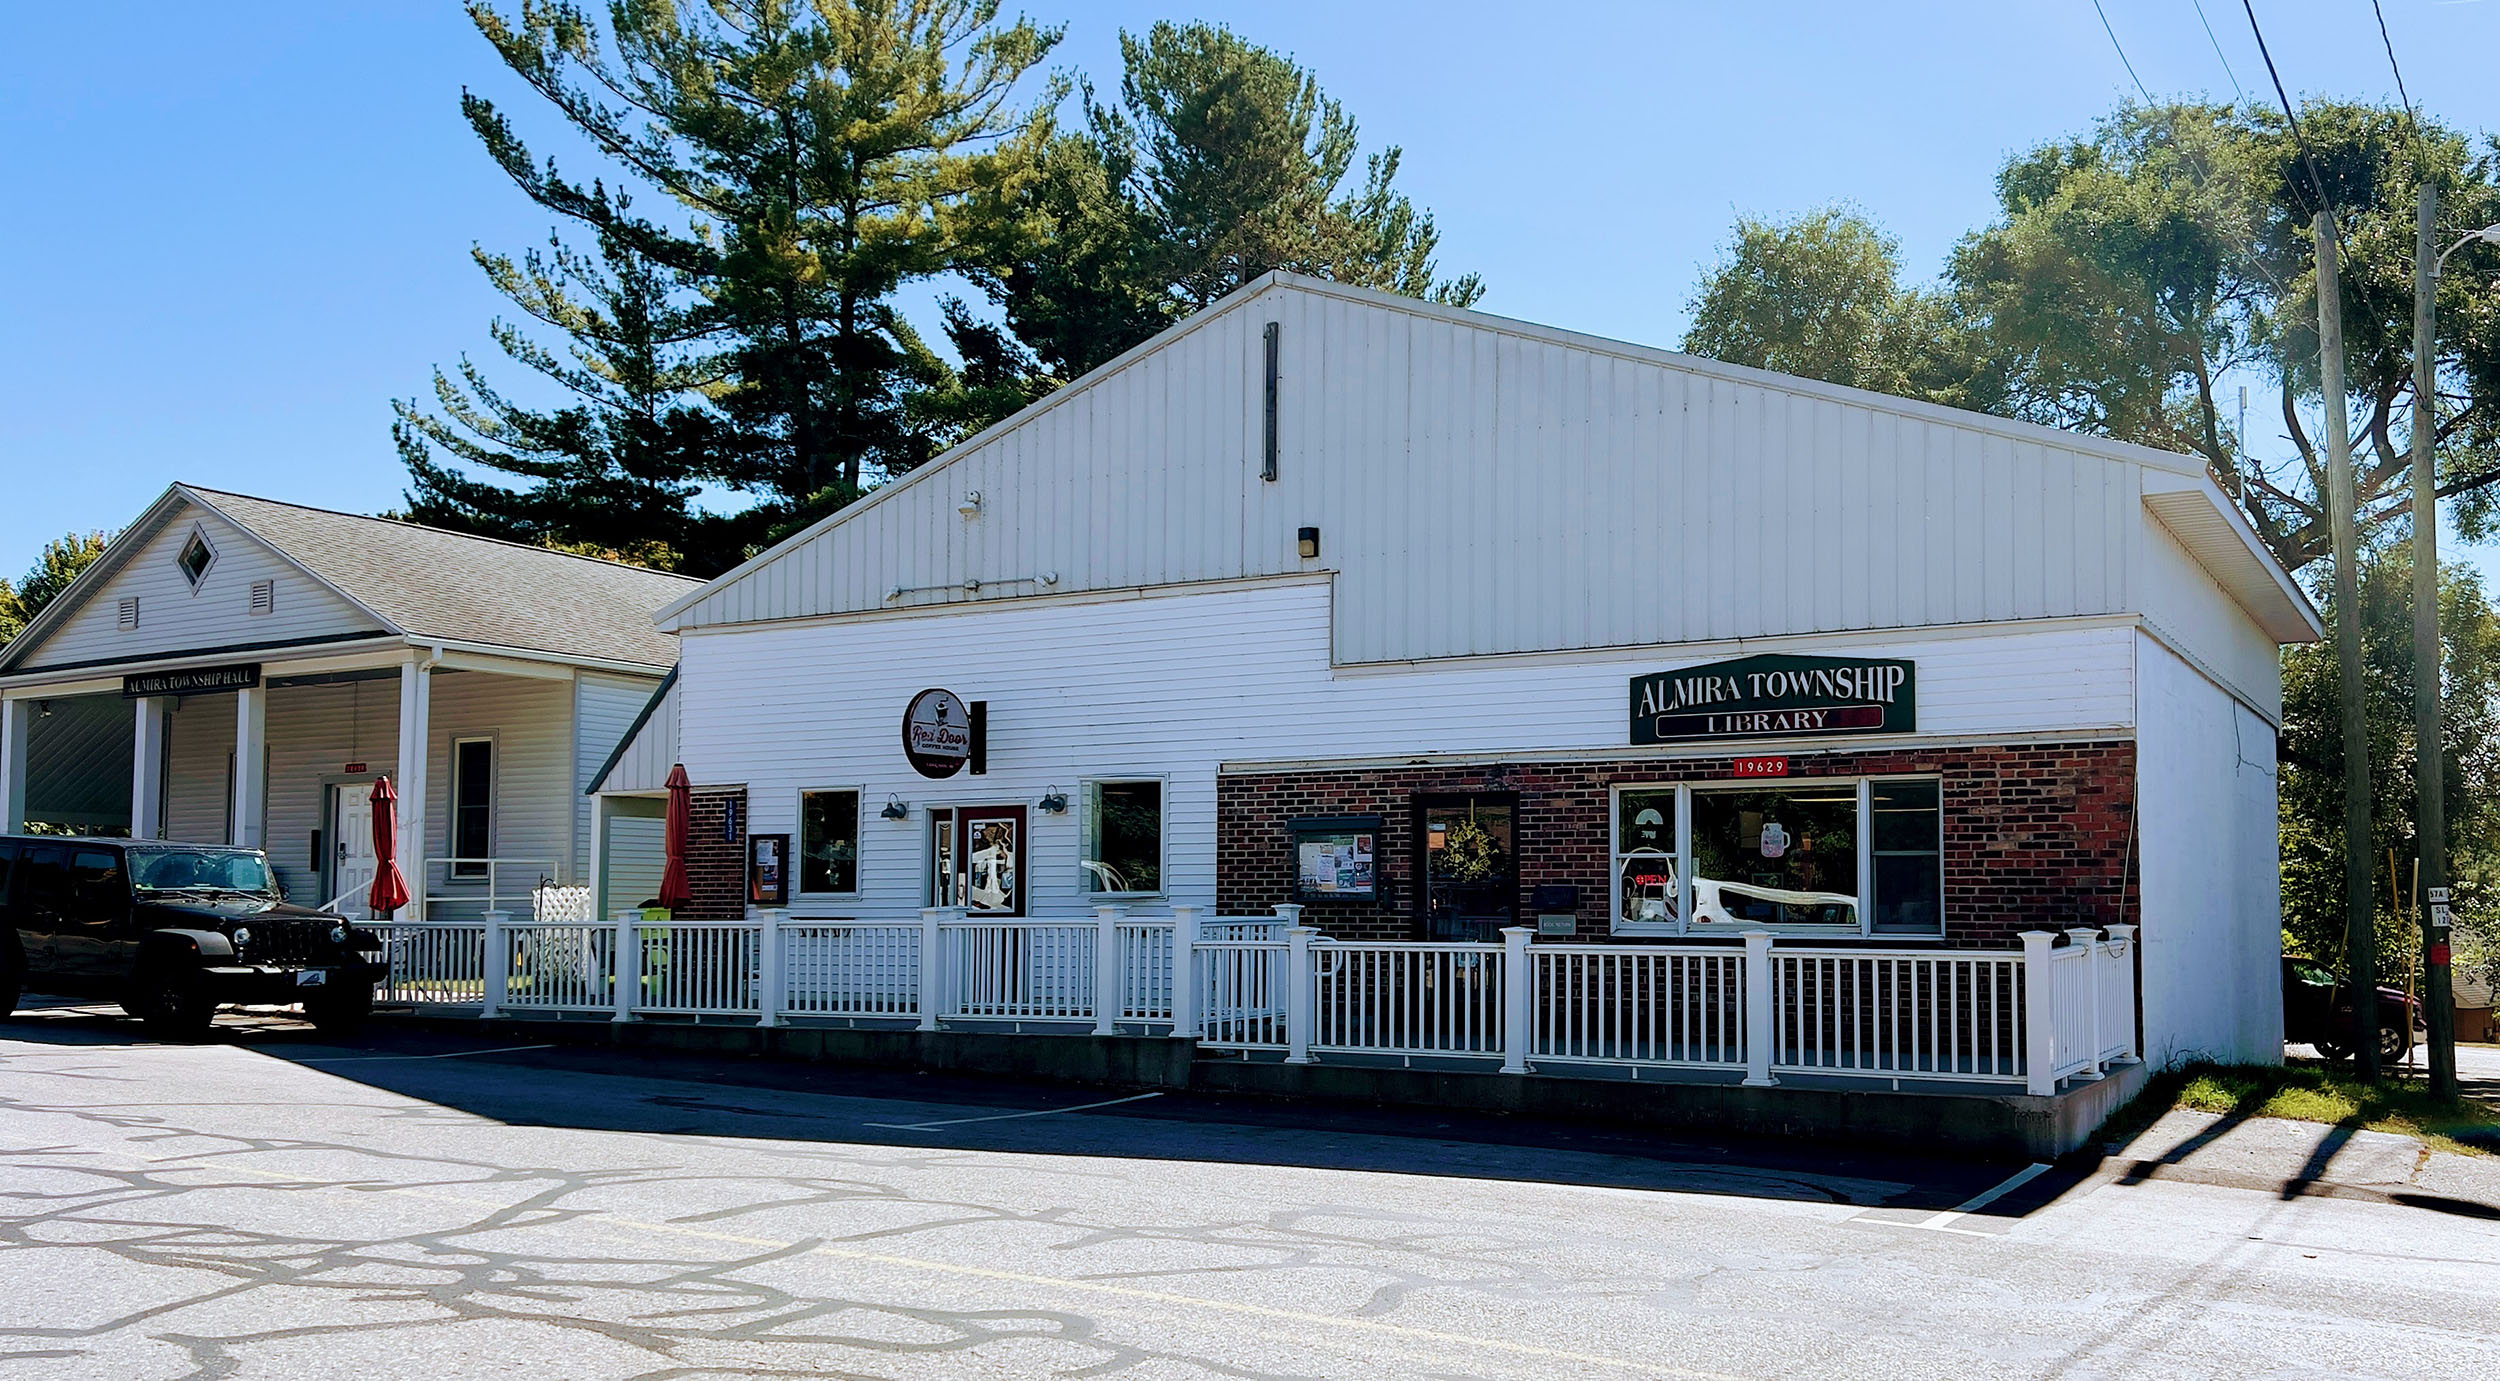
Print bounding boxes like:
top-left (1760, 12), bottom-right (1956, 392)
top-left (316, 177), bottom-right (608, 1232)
top-left (0, 836), bottom-right (385, 1038)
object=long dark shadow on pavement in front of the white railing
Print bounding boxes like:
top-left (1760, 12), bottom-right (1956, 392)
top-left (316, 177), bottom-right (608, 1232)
top-left (0, 998), bottom-right (2050, 1218)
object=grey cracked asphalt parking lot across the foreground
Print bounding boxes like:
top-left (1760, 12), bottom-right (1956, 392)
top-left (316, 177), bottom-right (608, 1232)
top-left (0, 1008), bottom-right (2500, 1381)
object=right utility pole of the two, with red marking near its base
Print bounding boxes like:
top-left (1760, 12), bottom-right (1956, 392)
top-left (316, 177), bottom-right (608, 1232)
top-left (2413, 180), bottom-right (2458, 1098)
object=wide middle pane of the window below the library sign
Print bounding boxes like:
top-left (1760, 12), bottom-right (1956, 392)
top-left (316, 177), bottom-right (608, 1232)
top-left (1693, 781), bottom-right (1858, 928)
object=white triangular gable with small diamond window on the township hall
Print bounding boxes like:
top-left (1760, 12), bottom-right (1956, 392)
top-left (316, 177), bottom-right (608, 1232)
top-left (25, 503), bottom-right (380, 670)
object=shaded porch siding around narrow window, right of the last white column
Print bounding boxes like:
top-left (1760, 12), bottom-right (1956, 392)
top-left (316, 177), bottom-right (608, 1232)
top-left (430, 670), bottom-right (580, 886)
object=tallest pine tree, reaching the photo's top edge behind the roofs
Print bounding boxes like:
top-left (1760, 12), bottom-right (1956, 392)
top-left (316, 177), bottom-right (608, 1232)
top-left (463, 0), bottom-right (1058, 535)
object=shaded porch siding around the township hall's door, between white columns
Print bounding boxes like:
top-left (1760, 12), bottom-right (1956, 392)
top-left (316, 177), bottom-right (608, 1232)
top-left (261, 675), bottom-right (400, 906)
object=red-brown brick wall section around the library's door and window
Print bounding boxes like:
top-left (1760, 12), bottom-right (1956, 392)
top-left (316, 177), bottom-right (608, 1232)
top-left (1215, 743), bottom-right (2135, 946)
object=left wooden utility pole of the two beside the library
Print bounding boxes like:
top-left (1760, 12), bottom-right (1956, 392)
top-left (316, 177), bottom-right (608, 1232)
top-left (2315, 208), bottom-right (2378, 1083)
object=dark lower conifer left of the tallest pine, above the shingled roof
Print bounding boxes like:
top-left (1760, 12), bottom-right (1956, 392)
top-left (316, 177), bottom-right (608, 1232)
top-left (390, 200), bottom-right (743, 575)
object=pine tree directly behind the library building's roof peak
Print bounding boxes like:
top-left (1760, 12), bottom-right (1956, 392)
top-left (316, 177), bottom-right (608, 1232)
top-left (978, 23), bottom-right (1485, 378)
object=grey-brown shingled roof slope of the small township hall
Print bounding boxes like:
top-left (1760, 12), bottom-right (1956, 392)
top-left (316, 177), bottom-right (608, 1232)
top-left (183, 485), bottom-right (698, 668)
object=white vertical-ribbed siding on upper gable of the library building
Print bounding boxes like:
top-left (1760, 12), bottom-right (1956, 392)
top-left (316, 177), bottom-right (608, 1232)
top-left (673, 280), bottom-right (2198, 663)
